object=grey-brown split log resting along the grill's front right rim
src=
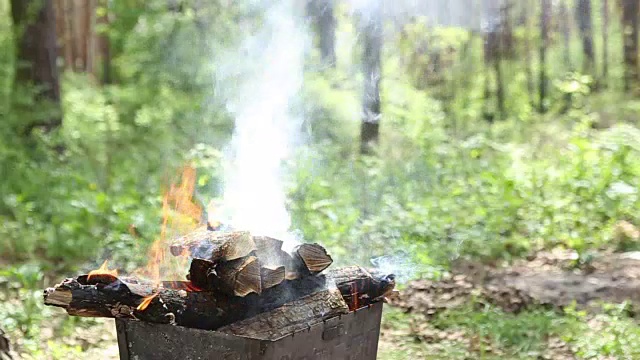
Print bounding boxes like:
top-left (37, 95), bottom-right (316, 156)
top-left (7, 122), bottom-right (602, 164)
top-left (217, 289), bottom-right (349, 340)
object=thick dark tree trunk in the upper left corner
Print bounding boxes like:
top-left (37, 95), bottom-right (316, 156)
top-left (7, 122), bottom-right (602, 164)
top-left (11, 0), bottom-right (62, 135)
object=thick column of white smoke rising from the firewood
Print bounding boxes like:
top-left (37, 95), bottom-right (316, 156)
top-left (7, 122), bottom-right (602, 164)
top-left (210, 0), bottom-right (309, 252)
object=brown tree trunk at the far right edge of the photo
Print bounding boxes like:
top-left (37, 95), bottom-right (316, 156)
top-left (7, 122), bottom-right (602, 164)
top-left (622, 0), bottom-right (640, 91)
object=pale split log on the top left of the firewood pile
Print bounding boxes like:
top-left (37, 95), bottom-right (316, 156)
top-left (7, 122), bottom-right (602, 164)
top-left (170, 226), bottom-right (256, 262)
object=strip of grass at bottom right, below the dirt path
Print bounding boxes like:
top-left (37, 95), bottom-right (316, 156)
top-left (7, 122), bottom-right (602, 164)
top-left (378, 304), bottom-right (640, 360)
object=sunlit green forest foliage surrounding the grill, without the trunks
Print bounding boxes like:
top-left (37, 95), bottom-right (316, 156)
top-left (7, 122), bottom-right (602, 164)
top-left (0, 0), bottom-right (640, 359)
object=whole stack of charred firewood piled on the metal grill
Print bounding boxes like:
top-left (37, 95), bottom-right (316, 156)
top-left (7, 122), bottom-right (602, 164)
top-left (44, 227), bottom-right (395, 339)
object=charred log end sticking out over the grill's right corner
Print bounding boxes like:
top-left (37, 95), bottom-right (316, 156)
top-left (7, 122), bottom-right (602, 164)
top-left (327, 266), bottom-right (396, 311)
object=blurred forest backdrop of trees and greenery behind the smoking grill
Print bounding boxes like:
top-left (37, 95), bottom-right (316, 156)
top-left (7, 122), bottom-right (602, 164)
top-left (0, 0), bottom-right (640, 359)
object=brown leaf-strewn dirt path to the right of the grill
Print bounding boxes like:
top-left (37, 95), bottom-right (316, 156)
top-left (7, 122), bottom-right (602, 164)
top-left (392, 250), bottom-right (640, 314)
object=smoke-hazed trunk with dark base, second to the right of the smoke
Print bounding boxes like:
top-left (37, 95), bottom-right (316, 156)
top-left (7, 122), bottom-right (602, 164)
top-left (360, 0), bottom-right (383, 154)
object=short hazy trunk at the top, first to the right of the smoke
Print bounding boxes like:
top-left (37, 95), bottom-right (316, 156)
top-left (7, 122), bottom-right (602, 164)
top-left (308, 0), bottom-right (336, 67)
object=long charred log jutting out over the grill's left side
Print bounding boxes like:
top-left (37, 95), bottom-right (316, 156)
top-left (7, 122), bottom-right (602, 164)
top-left (44, 275), bottom-right (327, 330)
